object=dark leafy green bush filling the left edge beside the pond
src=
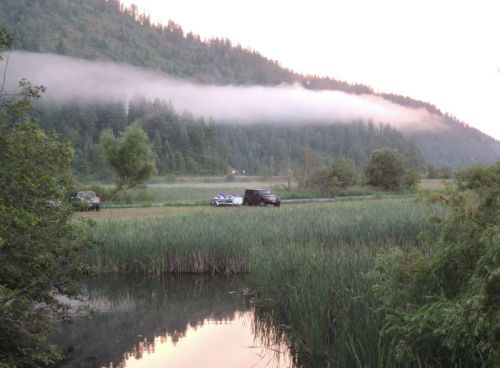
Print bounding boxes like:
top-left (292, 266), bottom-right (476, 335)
top-left (0, 28), bottom-right (86, 367)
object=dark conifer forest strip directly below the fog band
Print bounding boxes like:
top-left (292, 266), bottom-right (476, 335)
top-left (35, 98), bottom-right (415, 180)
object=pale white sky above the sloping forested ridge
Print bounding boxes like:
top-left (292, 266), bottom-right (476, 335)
top-left (122, 0), bottom-right (500, 140)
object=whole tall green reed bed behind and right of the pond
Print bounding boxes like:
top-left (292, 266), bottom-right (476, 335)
top-left (83, 198), bottom-right (430, 367)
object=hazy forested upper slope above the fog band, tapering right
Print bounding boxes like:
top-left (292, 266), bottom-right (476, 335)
top-left (0, 0), bottom-right (296, 84)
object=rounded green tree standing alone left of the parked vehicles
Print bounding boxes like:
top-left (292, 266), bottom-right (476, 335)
top-left (101, 123), bottom-right (157, 189)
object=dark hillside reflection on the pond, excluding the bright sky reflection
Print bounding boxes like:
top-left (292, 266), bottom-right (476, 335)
top-left (52, 276), bottom-right (247, 368)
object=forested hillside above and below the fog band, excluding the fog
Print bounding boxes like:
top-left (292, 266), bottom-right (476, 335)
top-left (0, 0), bottom-right (500, 175)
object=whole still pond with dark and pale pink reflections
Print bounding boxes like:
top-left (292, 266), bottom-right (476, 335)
top-left (51, 276), bottom-right (292, 368)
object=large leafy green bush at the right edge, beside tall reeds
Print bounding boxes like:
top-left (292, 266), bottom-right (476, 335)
top-left (376, 161), bottom-right (500, 367)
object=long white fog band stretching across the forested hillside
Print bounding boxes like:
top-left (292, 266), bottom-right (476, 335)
top-left (1, 51), bottom-right (441, 131)
